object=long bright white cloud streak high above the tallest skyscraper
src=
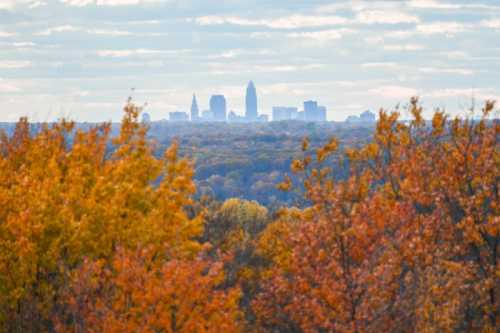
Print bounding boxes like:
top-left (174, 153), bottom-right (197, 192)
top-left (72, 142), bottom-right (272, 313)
top-left (195, 15), bottom-right (348, 29)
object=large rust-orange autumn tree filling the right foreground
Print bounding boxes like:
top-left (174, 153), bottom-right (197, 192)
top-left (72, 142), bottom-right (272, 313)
top-left (253, 99), bottom-right (500, 332)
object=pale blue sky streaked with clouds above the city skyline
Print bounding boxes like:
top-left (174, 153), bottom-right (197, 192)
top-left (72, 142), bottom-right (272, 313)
top-left (0, 0), bottom-right (500, 122)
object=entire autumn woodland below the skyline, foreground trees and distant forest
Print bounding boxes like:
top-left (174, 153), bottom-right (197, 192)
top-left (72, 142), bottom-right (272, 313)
top-left (0, 98), bottom-right (500, 332)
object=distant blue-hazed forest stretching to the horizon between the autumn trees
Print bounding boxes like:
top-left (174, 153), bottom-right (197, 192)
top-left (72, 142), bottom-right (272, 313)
top-left (0, 116), bottom-right (374, 205)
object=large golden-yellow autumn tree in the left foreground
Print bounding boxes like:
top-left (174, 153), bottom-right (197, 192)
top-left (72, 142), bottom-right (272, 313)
top-left (0, 101), bottom-right (242, 332)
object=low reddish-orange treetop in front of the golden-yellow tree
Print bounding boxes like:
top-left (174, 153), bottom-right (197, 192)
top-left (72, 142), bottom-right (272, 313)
top-left (55, 249), bottom-right (242, 333)
